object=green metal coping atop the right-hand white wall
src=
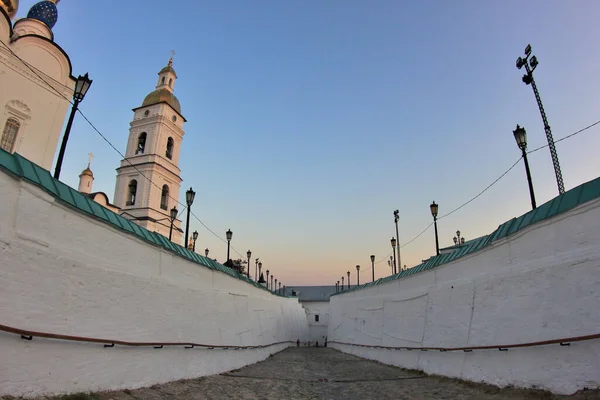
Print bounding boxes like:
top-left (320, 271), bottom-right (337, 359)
top-left (333, 173), bottom-right (600, 296)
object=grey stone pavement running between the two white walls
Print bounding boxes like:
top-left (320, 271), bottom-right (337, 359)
top-left (12, 347), bottom-right (600, 400)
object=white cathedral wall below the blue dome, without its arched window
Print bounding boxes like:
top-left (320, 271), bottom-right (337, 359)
top-left (0, 33), bottom-right (75, 170)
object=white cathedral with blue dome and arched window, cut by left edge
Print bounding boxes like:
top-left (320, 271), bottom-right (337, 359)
top-left (0, 0), bottom-right (75, 170)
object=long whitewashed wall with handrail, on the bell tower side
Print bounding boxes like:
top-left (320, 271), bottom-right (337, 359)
top-left (0, 171), bottom-right (308, 397)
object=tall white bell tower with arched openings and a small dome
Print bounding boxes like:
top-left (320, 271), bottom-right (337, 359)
top-left (114, 58), bottom-right (186, 244)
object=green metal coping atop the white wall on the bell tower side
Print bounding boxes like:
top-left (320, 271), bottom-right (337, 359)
top-left (0, 149), bottom-right (289, 297)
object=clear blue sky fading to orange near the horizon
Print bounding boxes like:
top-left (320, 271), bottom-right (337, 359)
top-left (19, 0), bottom-right (600, 286)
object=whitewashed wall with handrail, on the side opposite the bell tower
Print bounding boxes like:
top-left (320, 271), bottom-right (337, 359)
top-left (328, 200), bottom-right (600, 394)
